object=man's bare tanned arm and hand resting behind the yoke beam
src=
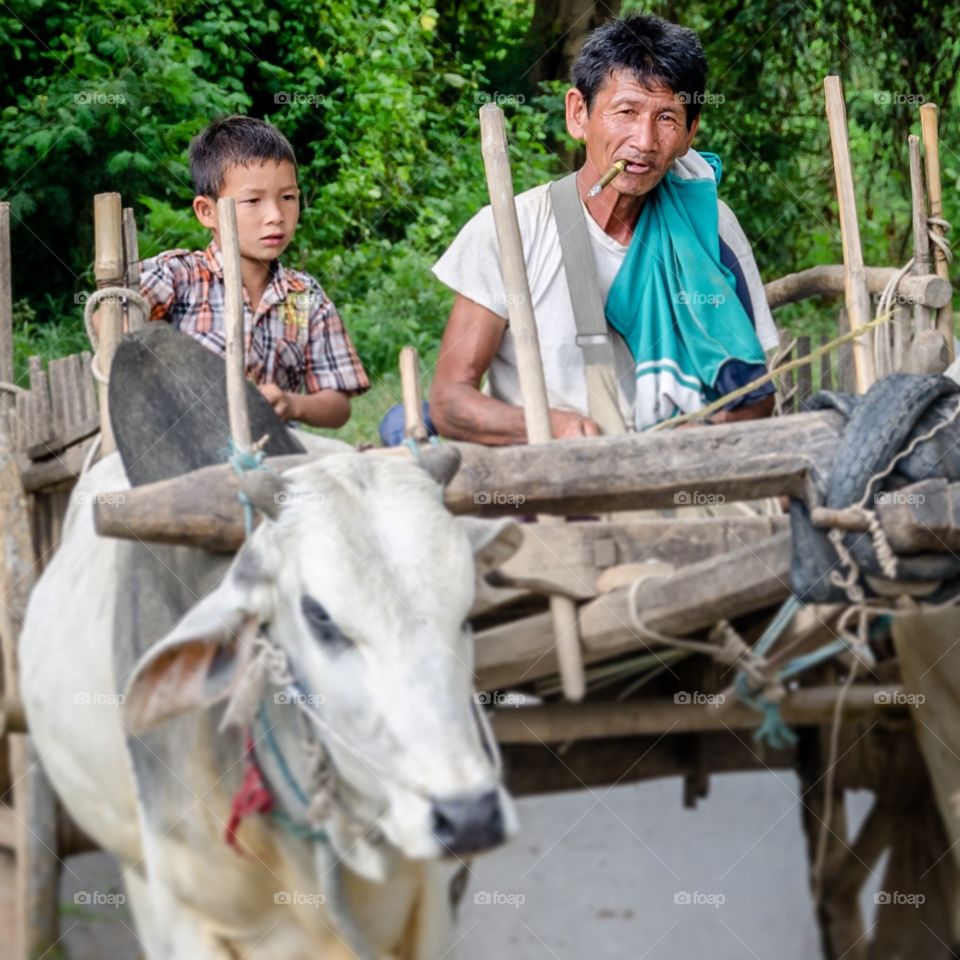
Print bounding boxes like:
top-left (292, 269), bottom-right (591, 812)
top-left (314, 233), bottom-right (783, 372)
top-left (430, 294), bottom-right (600, 446)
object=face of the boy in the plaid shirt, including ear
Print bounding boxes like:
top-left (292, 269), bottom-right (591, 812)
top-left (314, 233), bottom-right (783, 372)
top-left (193, 160), bottom-right (300, 262)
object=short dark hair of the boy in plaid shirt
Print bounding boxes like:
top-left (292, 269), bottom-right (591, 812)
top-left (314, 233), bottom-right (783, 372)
top-left (190, 115), bottom-right (297, 200)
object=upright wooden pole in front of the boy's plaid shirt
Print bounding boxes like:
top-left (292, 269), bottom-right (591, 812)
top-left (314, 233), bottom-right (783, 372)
top-left (217, 197), bottom-right (251, 452)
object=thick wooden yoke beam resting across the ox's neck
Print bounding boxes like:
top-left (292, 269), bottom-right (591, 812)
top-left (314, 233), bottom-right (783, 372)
top-left (94, 411), bottom-right (843, 551)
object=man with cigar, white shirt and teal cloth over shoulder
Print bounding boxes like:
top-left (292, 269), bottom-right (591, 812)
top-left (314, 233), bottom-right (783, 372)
top-left (431, 16), bottom-right (777, 444)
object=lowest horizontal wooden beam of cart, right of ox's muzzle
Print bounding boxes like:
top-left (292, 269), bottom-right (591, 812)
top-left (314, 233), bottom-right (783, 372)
top-left (491, 684), bottom-right (906, 743)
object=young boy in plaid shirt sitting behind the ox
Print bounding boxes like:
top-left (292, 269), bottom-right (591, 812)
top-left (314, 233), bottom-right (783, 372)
top-left (128, 116), bottom-right (370, 427)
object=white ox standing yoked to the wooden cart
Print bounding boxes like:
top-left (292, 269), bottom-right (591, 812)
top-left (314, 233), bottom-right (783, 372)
top-left (21, 452), bottom-right (519, 960)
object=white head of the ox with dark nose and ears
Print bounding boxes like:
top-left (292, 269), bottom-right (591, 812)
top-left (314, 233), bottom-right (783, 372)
top-left (125, 453), bottom-right (522, 866)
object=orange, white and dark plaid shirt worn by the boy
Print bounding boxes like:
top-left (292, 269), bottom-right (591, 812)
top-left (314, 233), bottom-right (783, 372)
top-left (140, 242), bottom-right (370, 396)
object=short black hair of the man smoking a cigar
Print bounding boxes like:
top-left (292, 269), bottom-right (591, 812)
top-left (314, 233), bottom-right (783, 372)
top-left (573, 14), bottom-right (707, 130)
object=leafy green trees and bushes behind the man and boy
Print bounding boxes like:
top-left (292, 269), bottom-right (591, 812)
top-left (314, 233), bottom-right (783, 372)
top-left (0, 0), bottom-right (960, 436)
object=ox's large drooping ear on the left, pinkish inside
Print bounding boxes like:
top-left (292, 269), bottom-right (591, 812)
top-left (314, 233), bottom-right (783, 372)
top-left (123, 576), bottom-right (259, 736)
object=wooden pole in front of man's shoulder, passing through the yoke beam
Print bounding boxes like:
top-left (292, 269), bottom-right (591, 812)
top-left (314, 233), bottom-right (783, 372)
top-left (480, 103), bottom-right (586, 701)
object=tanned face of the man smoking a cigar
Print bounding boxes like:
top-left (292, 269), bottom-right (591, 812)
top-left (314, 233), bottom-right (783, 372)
top-left (566, 70), bottom-right (700, 196)
